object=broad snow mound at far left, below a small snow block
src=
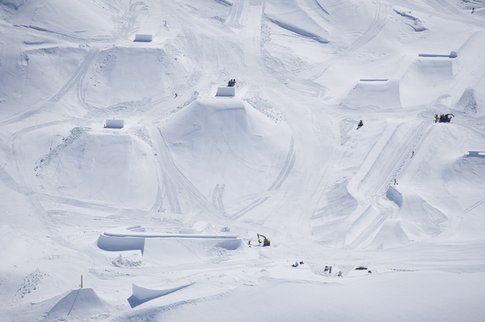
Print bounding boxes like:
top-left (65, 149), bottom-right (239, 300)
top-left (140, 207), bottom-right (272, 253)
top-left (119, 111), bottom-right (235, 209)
top-left (36, 128), bottom-right (158, 209)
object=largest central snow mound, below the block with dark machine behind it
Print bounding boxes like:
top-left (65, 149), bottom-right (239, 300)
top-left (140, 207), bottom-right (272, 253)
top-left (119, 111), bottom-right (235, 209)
top-left (162, 98), bottom-right (294, 211)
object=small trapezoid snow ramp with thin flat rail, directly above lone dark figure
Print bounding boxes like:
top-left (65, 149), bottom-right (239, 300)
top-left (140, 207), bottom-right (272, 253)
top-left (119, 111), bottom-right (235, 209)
top-left (341, 80), bottom-right (401, 109)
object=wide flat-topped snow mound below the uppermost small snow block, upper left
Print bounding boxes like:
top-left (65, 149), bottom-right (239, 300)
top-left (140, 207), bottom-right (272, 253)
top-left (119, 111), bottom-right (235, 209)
top-left (83, 47), bottom-right (188, 108)
